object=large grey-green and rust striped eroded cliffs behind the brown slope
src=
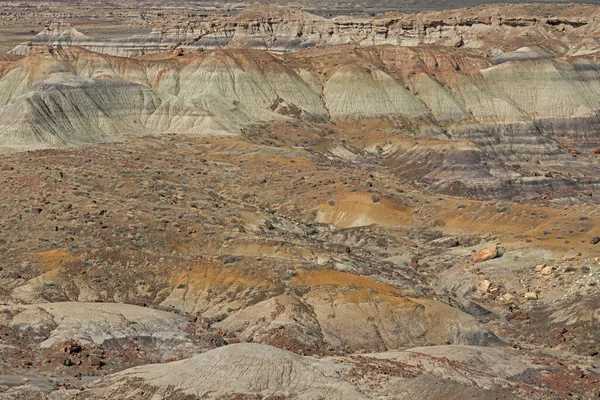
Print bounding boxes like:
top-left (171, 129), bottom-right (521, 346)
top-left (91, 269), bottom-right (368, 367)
top-left (0, 46), bottom-right (600, 203)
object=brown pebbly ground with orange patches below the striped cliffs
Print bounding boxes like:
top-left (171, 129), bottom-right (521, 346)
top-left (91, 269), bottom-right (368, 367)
top-left (0, 123), bottom-right (600, 393)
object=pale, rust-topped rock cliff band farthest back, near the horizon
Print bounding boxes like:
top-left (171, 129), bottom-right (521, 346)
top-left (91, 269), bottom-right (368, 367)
top-left (12, 5), bottom-right (600, 57)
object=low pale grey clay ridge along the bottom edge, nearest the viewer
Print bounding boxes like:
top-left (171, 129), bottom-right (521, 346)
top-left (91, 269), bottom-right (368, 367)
top-left (70, 344), bottom-right (539, 399)
